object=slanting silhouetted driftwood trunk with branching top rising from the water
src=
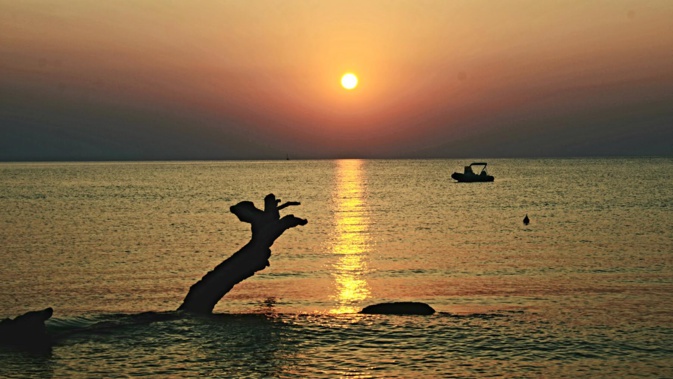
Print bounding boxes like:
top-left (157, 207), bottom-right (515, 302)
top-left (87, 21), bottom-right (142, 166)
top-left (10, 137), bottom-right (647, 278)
top-left (178, 194), bottom-right (308, 314)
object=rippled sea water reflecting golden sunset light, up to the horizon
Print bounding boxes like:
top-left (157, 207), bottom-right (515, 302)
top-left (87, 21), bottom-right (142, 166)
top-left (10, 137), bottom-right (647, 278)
top-left (0, 158), bottom-right (673, 378)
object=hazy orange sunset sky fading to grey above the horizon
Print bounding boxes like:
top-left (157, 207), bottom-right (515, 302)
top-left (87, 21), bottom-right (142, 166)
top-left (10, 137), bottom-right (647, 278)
top-left (0, 0), bottom-right (673, 160)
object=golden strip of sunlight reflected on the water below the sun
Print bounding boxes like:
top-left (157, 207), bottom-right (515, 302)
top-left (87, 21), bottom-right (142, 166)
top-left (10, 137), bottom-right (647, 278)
top-left (330, 160), bottom-right (370, 314)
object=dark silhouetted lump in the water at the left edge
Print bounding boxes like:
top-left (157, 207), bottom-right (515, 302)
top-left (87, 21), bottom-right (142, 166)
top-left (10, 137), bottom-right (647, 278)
top-left (0, 308), bottom-right (54, 349)
